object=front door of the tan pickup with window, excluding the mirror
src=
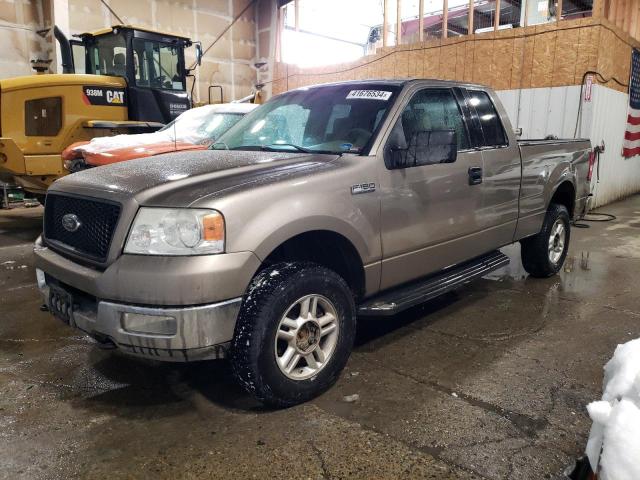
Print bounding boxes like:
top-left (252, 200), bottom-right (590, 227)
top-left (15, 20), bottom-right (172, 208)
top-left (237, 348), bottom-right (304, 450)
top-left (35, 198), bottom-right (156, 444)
top-left (379, 88), bottom-right (483, 289)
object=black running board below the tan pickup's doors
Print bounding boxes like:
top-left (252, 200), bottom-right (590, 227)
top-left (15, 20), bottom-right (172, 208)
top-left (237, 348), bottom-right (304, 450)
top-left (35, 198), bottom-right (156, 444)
top-left (358, 250), bottom-right (509, 316)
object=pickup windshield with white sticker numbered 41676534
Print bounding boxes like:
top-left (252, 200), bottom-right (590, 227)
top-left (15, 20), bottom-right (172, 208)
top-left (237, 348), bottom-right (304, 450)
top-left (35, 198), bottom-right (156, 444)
top-left (212, 84), bottom-right (399, 153)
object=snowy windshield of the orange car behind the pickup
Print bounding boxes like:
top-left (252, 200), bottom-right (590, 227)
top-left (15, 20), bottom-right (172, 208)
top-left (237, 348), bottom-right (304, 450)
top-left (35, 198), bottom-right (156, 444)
top-left (160, 108), bottom-right (244, 144)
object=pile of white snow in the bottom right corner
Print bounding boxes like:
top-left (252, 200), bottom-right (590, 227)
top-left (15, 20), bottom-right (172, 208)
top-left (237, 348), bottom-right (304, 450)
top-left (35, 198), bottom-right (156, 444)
top-left (587, 338), bottom-right (640, 480)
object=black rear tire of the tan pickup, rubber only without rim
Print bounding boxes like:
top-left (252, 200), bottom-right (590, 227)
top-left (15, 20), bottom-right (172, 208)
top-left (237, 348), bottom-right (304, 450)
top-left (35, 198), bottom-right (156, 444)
top-left (520, 203), bottom-right (571, 278)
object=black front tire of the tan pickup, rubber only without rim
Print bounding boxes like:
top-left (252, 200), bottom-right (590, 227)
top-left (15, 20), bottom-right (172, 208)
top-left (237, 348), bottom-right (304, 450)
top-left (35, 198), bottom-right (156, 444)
top-left (231, 262), bottom-right (356, 408)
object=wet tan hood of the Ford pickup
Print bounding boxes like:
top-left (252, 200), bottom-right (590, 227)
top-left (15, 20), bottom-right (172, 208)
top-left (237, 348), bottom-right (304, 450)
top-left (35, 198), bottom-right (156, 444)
top-left (51, 150), bottom-right (338, 206)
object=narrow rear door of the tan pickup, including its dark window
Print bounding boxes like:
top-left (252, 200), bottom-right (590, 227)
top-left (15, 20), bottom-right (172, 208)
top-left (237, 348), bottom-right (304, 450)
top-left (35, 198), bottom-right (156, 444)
top-left (463, 88), bottom-right (521, 247)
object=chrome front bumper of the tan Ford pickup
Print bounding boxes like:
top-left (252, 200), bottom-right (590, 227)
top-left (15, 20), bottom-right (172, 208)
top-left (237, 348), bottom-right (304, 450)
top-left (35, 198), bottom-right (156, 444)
top-left (36, 269), bottom-right (242, 362)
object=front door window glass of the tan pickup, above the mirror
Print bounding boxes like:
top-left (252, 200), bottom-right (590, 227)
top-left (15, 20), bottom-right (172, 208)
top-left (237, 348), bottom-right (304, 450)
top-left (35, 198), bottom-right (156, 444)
top-left (399, 88), bottom-right (469, 150)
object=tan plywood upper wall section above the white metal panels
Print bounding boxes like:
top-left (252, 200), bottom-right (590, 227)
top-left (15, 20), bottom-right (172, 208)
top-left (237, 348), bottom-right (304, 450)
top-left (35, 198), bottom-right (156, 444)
top-left (273, 17), bottom-right (640, 94)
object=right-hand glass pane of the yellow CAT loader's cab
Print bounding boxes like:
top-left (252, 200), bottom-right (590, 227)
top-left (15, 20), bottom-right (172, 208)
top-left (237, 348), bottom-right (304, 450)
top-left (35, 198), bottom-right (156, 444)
top-left (133, 38), bottom-right (185, 90)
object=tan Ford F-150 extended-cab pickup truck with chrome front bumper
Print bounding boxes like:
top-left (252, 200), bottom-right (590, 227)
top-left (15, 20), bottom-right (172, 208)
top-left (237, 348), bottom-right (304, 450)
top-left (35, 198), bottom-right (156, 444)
top-left (35, 80), bottom-right (591, 406)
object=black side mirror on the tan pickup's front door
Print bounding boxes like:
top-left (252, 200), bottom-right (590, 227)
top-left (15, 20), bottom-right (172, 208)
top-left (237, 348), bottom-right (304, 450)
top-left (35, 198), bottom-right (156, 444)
top-left (388, 130), bottom-right (458, 169)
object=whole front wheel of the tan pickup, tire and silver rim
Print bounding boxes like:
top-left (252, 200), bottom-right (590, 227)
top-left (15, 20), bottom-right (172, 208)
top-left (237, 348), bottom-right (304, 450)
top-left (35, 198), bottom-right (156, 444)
top-left (231, 262), bottom-right (356, 407)
